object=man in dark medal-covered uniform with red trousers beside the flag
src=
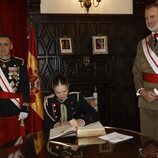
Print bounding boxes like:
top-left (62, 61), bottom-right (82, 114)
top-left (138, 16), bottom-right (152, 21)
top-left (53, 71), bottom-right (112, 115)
top-left (0, 35), bottom-right (30, 144)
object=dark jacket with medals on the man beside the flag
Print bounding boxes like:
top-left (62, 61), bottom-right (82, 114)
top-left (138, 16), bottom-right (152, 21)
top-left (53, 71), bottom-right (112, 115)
top-left (0, 57), bottom-right (30, 117)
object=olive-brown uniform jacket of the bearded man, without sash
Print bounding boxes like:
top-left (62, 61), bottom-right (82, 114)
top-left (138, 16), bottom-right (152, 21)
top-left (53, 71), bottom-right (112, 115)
top-left (133, 34), bottom-right (158, 110)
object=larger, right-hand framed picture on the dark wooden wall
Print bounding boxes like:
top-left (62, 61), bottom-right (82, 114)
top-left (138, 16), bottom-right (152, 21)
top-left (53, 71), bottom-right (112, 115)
top-left (92, 36), bottom-right (108, 54)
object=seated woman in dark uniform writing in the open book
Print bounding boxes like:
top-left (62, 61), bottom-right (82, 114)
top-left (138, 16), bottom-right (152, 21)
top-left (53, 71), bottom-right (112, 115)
top-left (44, 75), bottom-right (98, 129)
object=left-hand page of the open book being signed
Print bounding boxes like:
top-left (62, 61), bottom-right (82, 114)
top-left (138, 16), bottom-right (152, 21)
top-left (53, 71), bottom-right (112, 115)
top-left (49, 125), bottom-right (76, 140)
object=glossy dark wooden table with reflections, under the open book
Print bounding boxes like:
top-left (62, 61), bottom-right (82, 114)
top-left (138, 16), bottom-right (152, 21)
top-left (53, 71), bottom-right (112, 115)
top-left (0, 127), bottom-right (156, 158)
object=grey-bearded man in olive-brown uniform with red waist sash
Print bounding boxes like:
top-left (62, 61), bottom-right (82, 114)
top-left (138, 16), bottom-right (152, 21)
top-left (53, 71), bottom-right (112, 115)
top-left (133, 3), bottom-right (158, 141)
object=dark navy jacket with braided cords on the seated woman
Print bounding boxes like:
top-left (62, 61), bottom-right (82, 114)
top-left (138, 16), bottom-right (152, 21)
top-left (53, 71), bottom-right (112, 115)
top-left (44, 92), bottom-right (98, 129)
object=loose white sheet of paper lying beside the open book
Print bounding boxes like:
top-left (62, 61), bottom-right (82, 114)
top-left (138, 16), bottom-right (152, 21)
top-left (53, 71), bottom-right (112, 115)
top-left (99, 132), bottom-right (133, 143)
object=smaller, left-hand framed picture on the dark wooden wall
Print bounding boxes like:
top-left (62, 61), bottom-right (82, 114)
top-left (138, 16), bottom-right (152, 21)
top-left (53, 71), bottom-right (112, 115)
top-left (59, 37), bottom-right (72, 55)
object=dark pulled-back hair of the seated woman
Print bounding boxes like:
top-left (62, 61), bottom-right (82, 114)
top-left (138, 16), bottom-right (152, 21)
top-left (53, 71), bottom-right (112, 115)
top-left (52, 74), bottom-right (69, 88)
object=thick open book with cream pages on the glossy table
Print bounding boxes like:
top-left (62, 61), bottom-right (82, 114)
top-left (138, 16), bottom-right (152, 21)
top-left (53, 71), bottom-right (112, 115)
top-left (49, 121), bottom-right (106, 140)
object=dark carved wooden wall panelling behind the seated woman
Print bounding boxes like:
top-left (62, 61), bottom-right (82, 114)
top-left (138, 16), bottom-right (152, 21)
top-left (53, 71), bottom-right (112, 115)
top-left (27, 0), bottom-right (150, 130)
